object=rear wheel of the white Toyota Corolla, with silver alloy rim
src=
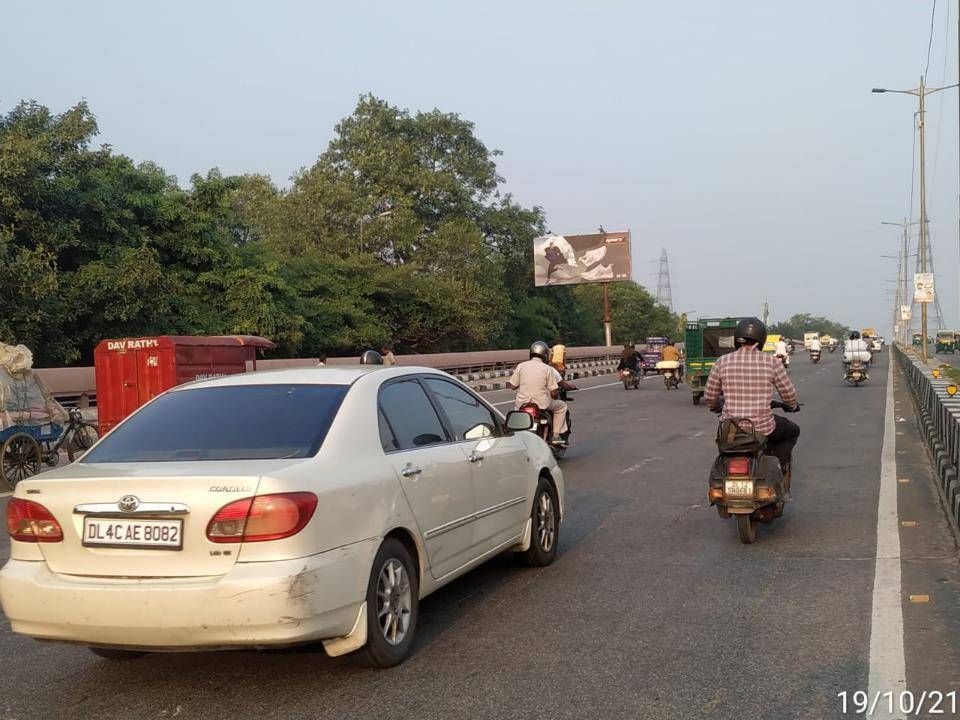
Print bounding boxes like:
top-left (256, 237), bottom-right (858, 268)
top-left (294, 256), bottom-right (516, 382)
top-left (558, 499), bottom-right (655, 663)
top-left (361, 538), bottom-right (420, 668)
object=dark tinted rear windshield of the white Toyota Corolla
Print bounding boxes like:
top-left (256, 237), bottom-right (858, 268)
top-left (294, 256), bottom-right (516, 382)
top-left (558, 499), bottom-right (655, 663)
top-left (83, 385), bottom-right (348, 463)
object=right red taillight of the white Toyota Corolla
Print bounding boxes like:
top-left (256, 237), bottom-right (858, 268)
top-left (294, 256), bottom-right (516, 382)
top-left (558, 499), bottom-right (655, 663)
top-left (207, 492), bottom-right (317, 543)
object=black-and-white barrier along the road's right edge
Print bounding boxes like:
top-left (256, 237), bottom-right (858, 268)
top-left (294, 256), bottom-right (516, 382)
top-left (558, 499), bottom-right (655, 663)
top-left (891, 345), bottom-right (960, 527)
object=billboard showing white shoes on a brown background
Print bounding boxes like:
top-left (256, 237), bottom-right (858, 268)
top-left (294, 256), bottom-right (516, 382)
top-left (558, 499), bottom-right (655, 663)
top-left (533, 231), bottom-right (630, 287)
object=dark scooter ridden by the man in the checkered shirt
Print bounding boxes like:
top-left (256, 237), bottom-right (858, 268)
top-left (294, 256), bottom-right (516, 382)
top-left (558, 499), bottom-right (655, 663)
top-left (707, 401), bottom-right (793, 544)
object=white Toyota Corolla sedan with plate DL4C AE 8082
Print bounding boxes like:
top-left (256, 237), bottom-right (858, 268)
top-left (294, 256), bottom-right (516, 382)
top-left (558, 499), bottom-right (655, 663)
top-left (0, 367), bottom-right (563, 666)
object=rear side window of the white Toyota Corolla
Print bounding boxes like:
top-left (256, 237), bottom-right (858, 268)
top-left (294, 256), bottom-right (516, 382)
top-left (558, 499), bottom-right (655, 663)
top-left (380, 379), bottom-right (448, 452)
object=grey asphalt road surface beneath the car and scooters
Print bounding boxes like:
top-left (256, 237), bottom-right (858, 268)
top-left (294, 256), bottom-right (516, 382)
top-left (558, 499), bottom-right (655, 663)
top-left (0, 352), bottom-right (960, 720)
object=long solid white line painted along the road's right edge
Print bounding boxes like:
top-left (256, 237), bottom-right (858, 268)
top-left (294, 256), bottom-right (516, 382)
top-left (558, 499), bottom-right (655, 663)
top-left (867, 363), bottom-right (907, 718)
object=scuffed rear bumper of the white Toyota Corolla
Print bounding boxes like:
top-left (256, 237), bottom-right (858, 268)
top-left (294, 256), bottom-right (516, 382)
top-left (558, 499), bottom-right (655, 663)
top-left (0, 539), bottom-right (379, 650)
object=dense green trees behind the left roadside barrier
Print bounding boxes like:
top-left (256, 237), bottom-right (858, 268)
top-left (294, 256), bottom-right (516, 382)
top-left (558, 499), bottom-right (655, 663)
top-left (0, 95), bottom-right (676, 366)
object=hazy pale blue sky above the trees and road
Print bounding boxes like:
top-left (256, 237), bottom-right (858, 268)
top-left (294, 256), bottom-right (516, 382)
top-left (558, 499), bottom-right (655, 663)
top-left (0, 0), bottom-right (960, 328)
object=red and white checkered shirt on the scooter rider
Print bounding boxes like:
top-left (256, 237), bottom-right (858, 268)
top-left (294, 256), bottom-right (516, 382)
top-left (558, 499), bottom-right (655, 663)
top-left (705, 346), bottom-right (797, 435)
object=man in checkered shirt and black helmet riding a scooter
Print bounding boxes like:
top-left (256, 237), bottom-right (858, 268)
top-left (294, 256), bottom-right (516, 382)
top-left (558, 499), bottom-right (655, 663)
top-left (705, 318), bottom-right (800, 474)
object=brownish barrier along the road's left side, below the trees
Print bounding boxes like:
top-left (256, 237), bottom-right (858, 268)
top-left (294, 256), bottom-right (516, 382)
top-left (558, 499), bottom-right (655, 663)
top-left (37, 346), bottom-right (642, 408)
